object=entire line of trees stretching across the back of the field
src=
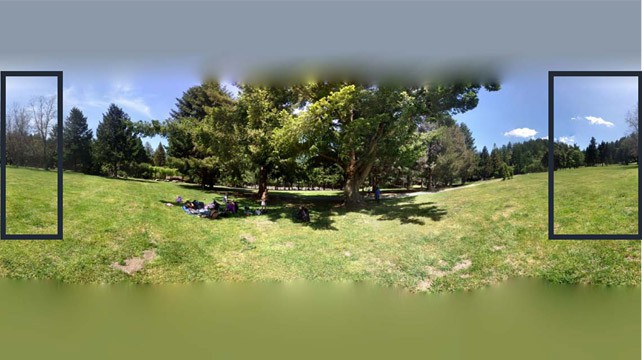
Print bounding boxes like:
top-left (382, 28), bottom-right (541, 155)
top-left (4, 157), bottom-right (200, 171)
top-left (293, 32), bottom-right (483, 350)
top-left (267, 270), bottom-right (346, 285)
top-left (7, 81), bottom-right (637, 205)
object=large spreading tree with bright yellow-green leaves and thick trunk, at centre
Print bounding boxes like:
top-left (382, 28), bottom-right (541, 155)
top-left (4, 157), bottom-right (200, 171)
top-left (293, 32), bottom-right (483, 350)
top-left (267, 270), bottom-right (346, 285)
top-left (277, 83), bottom-right (498, 206)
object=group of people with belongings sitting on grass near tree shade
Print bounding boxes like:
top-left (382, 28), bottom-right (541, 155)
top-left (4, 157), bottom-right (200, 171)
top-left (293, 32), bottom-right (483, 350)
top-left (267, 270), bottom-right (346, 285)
top-left (176, 192), bottom-right (267, 219)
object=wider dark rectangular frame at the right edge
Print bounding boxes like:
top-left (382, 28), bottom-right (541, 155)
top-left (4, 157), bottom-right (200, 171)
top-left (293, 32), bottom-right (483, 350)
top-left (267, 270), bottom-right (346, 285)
top-left (548, 71), bottom-right (642, 240)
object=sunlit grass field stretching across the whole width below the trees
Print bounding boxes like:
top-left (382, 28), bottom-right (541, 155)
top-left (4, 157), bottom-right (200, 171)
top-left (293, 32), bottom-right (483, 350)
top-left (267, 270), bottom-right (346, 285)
top-left (0, 166), bottom-right (640, 292)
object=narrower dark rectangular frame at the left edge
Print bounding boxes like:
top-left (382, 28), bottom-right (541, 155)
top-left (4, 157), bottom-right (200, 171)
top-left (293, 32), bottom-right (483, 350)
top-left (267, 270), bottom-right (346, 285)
top-left (0, 71), bottom-right (63, 240)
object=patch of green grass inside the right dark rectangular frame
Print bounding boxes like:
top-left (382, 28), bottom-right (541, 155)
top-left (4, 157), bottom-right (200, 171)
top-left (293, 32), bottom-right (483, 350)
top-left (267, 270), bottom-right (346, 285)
top-left (554, 165), bottom-right (638, 235)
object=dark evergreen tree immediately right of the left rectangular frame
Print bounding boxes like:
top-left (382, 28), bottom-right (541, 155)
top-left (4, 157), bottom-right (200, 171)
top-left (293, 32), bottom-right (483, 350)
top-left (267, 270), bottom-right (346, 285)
top-left (63, 107), bottom-right (94, 173)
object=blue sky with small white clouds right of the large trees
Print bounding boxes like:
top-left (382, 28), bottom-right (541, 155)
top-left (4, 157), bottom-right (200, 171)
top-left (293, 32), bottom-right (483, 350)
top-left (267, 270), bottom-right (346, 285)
top-left (455, 71), bottom-right (638, 150)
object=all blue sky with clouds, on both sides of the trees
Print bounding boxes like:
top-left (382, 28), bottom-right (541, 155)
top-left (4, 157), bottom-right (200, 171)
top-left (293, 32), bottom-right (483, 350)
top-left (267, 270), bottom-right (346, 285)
top-left (7, 63), bottom-right (637, 150)
